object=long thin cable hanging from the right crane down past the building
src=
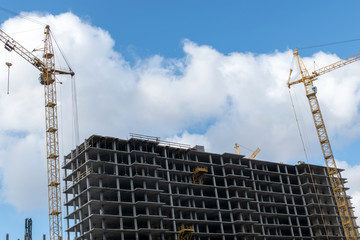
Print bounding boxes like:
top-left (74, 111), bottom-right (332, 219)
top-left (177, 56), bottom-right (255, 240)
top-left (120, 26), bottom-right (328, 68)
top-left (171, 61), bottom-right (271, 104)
top-left (288, 68), bottom-right (329, 240)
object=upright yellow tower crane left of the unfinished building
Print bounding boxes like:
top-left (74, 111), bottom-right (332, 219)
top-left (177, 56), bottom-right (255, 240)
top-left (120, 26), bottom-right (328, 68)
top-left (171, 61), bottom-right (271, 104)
top-left (0, 26), bottom-right (74, 240)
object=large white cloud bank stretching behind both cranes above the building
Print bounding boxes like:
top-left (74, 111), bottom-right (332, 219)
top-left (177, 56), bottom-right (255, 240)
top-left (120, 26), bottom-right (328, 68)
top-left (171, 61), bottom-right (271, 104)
top-left (0, 13), bottom-right (360, 216)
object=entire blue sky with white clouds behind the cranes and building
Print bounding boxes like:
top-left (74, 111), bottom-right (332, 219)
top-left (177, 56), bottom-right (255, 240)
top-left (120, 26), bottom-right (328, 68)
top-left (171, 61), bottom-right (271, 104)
top-left (0, 1), bottom-right (360, 238)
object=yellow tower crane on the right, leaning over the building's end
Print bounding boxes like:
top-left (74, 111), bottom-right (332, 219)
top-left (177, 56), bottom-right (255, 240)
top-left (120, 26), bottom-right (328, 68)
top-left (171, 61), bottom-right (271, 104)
top-left (287, 49), bottom-right (360, 240)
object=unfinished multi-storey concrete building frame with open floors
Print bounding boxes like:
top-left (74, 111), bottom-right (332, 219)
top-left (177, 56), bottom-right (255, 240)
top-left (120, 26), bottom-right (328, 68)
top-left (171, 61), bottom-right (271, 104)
top-left (63, 134), bottom-right (358, 240)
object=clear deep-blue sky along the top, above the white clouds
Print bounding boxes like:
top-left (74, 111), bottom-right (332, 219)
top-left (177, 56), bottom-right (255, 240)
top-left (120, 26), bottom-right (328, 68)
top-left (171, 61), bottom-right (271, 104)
top-left (0, 0), bottom-right (360, 57)
